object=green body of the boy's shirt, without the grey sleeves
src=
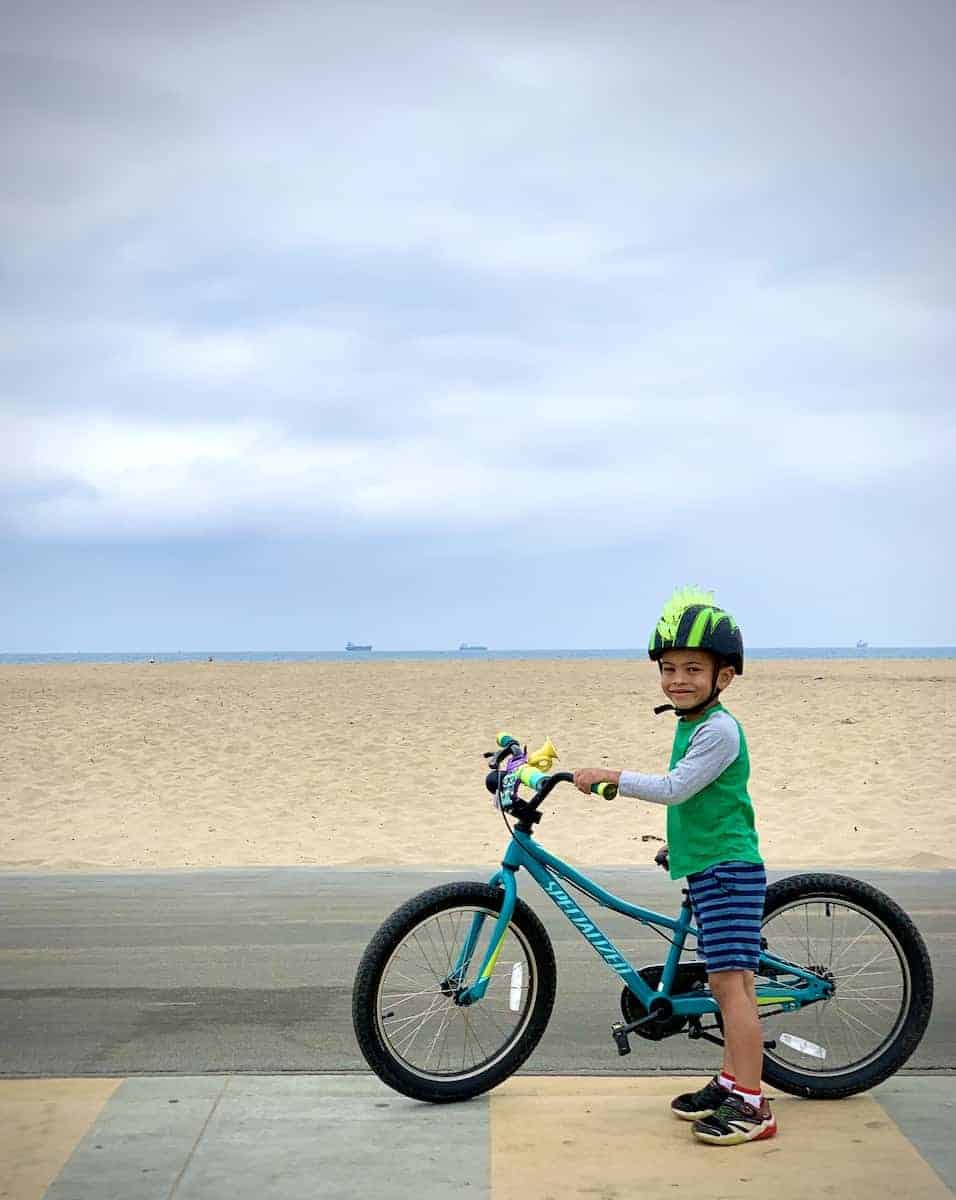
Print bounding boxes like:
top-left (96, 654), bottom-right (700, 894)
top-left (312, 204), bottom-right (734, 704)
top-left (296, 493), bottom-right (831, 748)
top-left (667, 704), bottom-right (763, 880)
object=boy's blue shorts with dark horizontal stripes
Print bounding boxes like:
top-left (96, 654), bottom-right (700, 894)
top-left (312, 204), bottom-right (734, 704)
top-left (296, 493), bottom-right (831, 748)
top-left (687, 863), bottom-right (766, 974)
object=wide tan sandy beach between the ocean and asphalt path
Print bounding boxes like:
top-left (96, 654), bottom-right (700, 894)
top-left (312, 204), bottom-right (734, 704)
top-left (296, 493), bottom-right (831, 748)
top-left (0, 659), bottom-right (956, 870)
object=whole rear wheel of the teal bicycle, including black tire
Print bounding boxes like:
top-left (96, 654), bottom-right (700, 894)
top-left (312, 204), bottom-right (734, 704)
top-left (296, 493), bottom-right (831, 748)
top-left (757, 874), bottom-right (933, 1099)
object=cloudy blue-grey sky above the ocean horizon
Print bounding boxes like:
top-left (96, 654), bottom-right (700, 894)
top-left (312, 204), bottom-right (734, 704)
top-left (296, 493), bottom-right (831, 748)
top-left (0, 0), bottom-right (956, 653)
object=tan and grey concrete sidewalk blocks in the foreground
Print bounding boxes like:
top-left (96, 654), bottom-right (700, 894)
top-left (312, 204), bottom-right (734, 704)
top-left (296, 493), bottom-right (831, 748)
top-left (0, 1075), bottom-right (956, 1200)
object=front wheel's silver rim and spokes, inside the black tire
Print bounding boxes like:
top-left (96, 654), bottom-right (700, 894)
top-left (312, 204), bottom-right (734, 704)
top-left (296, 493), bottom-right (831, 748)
top-left (375, 907), bottom-right (537, 1082)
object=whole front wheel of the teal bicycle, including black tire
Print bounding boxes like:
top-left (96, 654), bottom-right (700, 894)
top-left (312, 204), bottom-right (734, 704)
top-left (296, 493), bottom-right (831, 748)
top-left (351, 883), bottom-right (557, 1103)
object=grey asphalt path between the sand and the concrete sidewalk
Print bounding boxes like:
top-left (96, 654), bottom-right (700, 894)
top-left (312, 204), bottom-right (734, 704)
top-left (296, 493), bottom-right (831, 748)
top-left (0, 868), bottom-right (956, 1078)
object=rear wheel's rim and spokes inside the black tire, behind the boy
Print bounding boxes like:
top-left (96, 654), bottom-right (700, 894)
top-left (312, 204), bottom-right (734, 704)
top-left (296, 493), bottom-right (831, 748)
top-left (758, 895), bottom-right (913, 1076)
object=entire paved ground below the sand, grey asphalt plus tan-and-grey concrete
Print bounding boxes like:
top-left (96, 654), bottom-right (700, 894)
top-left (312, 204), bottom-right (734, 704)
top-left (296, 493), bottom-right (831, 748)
top-left (0, 868), bottom-right (956, 1200)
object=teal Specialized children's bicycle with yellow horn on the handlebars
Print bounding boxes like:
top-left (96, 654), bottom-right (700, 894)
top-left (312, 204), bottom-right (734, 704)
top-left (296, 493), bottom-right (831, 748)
top-left (353, 733), bottom-right (933, 1103)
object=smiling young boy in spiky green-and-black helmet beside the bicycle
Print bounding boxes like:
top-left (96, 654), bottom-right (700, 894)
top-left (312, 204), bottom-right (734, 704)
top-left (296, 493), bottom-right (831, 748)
top-left (575, 588), bottom-right (777, 1146)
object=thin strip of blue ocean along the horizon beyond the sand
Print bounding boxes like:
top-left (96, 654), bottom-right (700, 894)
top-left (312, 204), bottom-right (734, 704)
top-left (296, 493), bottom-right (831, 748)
top-left (0, 646), bottom-right (956, 666)
